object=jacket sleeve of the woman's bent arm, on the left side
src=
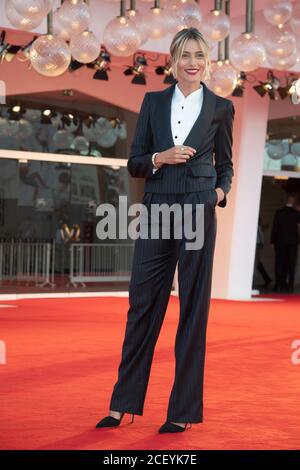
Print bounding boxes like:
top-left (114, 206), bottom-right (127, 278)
top-left (127, 93), bottom-right (153, 178)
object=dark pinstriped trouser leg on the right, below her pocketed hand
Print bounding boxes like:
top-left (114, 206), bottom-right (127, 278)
top-left (167, 192), bottom-right (217, 423)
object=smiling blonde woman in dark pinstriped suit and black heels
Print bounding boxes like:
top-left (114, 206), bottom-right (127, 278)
top-left (96, 28), bottom-right (234, 433)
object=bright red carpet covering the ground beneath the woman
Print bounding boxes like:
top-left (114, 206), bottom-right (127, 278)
top-left (0, 296), bottom-right (300, 450)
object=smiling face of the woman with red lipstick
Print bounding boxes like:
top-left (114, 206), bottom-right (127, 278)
top-left (177, 39), bottom-right (205, 84)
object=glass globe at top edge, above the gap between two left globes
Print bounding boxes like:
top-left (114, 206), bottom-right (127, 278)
top-left (58, 0), bottom-right (90, 34)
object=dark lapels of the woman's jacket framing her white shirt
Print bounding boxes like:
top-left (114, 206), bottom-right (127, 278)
top-left (161, 81), bottom-right (216, 152)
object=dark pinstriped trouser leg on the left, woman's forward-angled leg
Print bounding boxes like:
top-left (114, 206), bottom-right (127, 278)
top-left (110, 194), bottom-right (177, 415)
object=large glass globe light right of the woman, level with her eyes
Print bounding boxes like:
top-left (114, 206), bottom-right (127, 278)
top-left (230, 33), bottom-right (266, 72)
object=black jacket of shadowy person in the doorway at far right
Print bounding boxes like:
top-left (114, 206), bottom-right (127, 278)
top-left (271, 206), bottom-right (300, 245)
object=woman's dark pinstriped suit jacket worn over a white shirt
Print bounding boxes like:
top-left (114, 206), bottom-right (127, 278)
top-left (127, 82), bottom-right (235, 207)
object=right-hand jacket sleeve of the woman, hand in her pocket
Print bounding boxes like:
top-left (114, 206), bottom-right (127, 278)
top-left (214, 101), bottom-right (235, 207)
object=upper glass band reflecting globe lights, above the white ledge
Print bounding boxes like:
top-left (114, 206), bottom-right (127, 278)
top-left (0, 91), bottom-right (137, 158)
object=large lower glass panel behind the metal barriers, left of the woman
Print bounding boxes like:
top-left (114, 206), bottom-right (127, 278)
top-left (0, 159), bottom-right (142, 293)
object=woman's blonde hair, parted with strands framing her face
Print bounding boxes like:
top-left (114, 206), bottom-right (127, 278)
top-left (170, 28), bottom-right (211, 79)
